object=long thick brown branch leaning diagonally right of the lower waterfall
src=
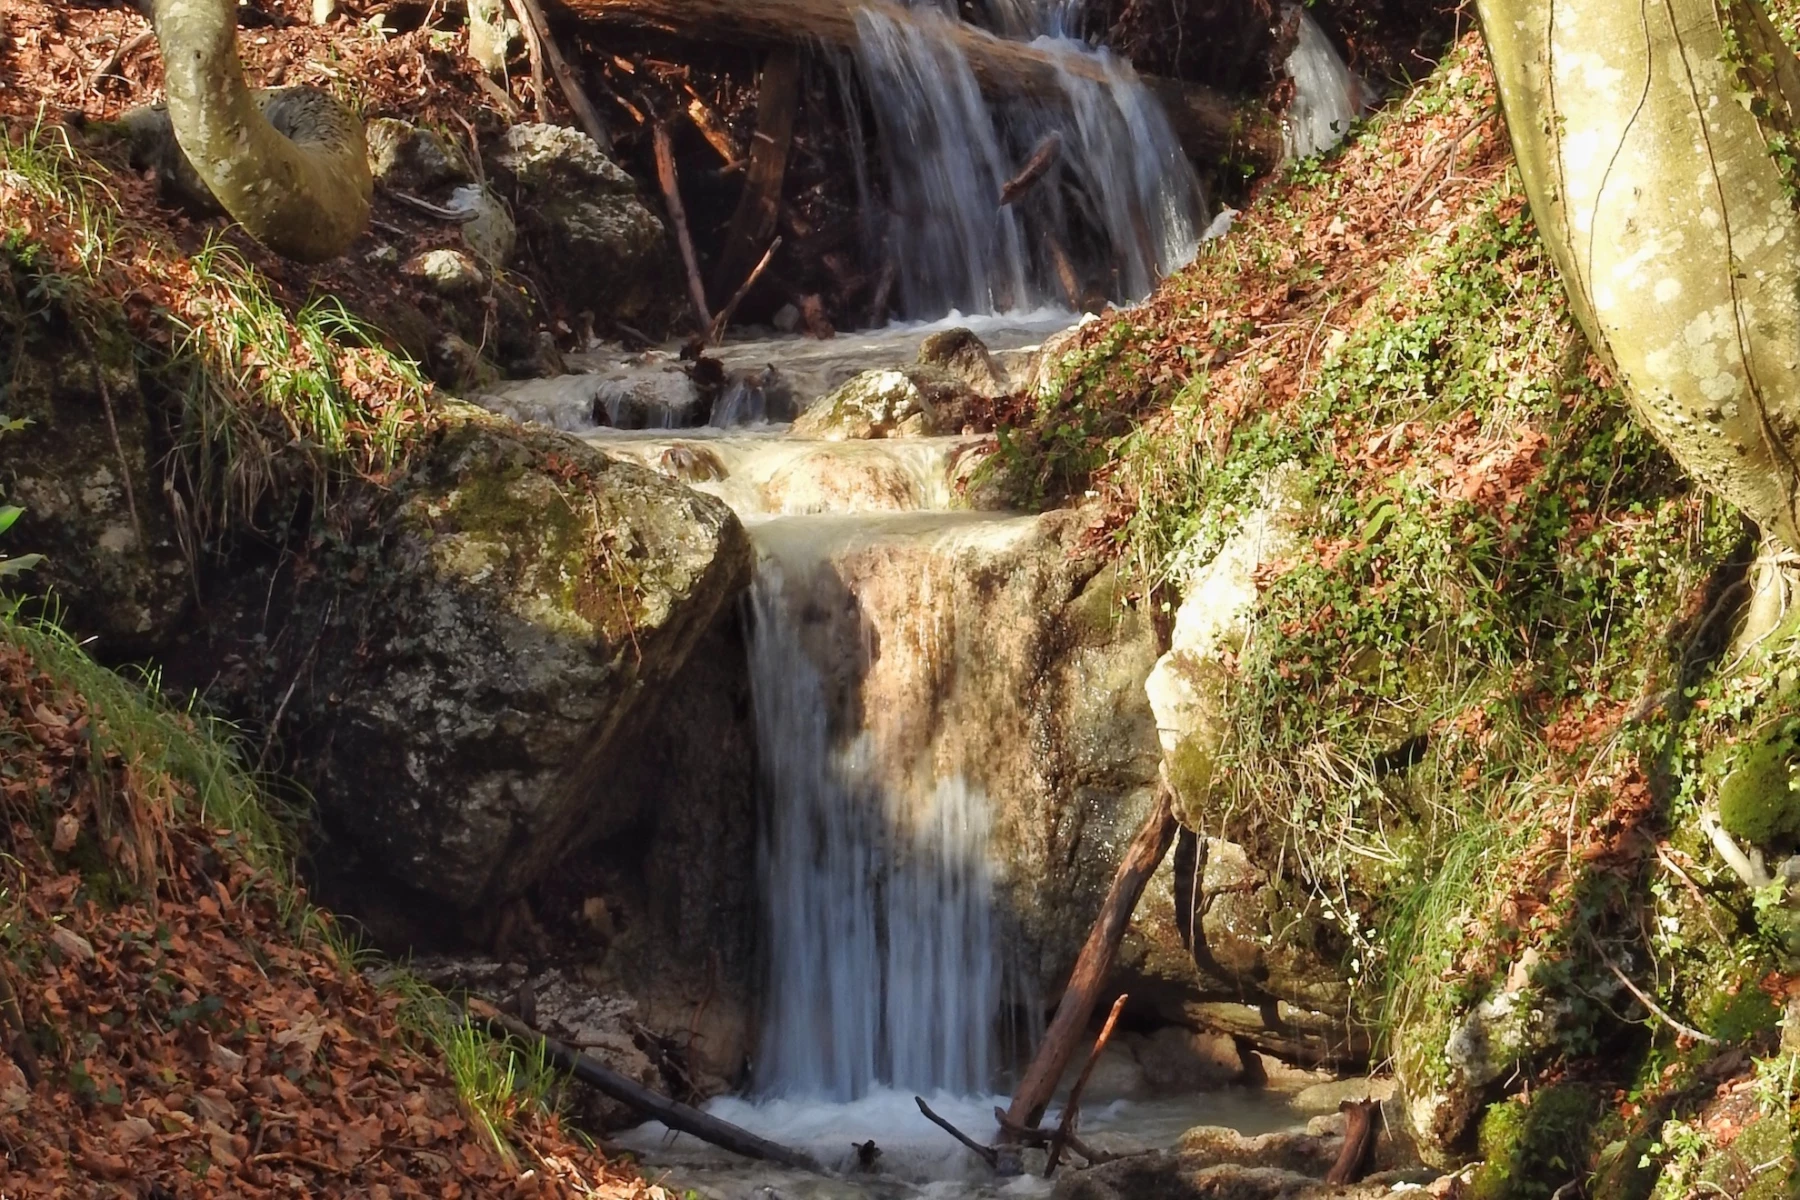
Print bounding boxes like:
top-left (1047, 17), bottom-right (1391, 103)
top-left (1006, 779), bottom-right (1175, 1126)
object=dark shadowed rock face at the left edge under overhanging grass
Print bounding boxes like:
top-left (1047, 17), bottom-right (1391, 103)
top-left (0, 300), bottom-right (193, 657)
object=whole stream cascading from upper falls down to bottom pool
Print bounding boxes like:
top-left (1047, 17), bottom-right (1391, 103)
top-left (482, 0), bottom-right (1361, 1200)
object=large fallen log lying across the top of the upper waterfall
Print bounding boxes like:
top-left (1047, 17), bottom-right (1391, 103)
top-left (553, 0), bottom-right (1282, 169)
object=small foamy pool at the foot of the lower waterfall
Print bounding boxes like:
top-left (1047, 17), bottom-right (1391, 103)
top-left (612, 1088), bottom-right (1309, 1200)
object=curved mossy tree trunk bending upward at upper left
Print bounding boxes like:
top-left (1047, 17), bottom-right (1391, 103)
top-left (155, 0), bottom-right (373, 263)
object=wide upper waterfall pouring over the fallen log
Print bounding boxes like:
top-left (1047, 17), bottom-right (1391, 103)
top-left (857, 0), bottom-right (1208, 318)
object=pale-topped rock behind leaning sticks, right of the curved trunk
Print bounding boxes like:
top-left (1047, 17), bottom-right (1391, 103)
top-left (493, 124), bottom-right (684, 335)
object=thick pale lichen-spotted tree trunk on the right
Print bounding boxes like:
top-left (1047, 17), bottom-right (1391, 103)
top-left (1478, 0), bottom-right (1800, 549)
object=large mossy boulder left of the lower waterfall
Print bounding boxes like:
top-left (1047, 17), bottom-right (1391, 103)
top-left (177, 405), bottom-right (751, 921)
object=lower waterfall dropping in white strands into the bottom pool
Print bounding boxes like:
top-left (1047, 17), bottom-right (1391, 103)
top-left (751, 536), bottom-right (1001, 1101)
